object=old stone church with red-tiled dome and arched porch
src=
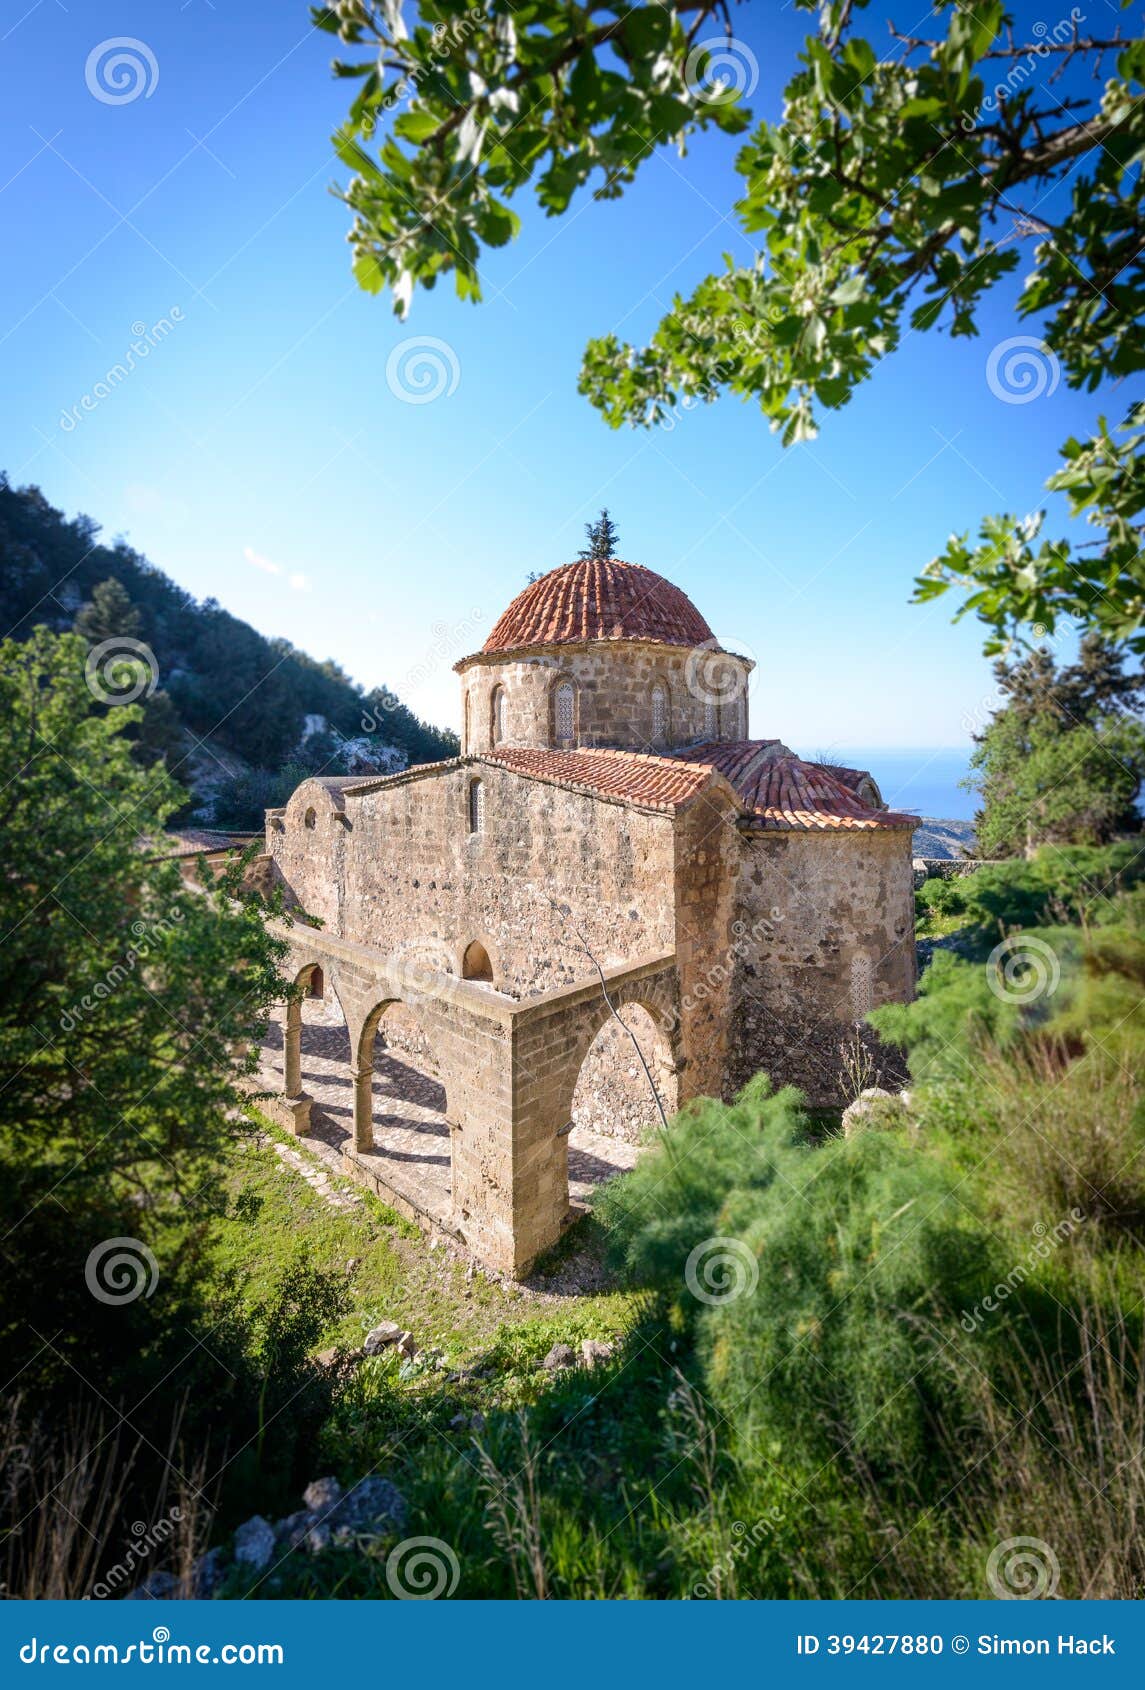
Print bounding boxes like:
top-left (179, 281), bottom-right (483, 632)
top-left (265, 558), bottom-right (917, 1274)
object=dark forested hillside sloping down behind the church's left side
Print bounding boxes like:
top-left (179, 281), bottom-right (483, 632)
top-left (0, 475), bottom-right (458, 826)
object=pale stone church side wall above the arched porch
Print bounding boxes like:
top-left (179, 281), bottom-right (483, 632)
top-left (267, 764), bottom-right (674, 995)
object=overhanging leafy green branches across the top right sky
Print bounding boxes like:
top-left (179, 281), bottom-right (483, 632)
top-left (314, 0), bottom-right (1145, 652)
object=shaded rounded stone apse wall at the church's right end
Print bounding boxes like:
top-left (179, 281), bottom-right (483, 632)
top-left (728, 830), bottom-right (915, 1105)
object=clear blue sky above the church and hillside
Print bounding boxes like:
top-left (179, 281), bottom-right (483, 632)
top-left (0, 0), bottom-right (1099, 752)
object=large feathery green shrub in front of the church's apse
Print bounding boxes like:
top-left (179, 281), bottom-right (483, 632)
top-left (605, 1077), bottom-right (993, 1493)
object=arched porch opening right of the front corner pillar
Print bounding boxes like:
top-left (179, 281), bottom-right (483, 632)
top-left (567, 1002), bottom-right (679, 1203)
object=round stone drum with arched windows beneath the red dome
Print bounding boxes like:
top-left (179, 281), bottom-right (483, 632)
top-left (459, 641), bottom-right (750, 752)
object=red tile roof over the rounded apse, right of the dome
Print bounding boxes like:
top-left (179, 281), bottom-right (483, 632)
top-left (684, 740), bottom-right (919, 833)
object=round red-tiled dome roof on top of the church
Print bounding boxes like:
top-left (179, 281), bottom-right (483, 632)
top-left (481, 558), bottom-right (714, 654)
